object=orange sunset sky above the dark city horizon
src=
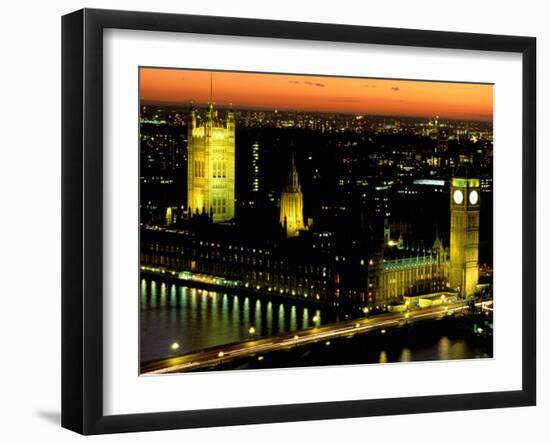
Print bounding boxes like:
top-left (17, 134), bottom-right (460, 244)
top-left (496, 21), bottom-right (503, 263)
top-left (140, 68), bottom-right (493, 121)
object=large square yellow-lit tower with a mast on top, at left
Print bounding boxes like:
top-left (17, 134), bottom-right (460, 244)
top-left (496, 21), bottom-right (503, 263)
top-left (187, 104), bottom-right (235, 223)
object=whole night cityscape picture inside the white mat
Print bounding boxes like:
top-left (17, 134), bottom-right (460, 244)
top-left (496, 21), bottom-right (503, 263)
top-left (139, 70), bottom-right (493, 374)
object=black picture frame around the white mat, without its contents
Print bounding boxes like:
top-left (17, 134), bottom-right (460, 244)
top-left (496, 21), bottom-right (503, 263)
top-left (62, 9), bottom-right (536, 434)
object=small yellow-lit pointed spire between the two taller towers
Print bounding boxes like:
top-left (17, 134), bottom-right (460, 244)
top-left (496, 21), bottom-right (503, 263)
top-left (279, 154), bottom-right (305, 237)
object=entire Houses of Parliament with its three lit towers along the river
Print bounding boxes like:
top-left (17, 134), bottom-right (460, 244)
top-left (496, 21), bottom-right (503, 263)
top-left (141, 104), bottom-right (480, 309)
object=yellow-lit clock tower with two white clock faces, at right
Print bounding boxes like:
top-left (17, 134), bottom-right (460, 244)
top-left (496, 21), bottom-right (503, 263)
top-left (449, 164), bottom-right (480, 297)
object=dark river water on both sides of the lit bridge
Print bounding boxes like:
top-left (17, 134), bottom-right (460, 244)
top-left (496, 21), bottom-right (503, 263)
top-left (140, 278), bottom-right (493, 370)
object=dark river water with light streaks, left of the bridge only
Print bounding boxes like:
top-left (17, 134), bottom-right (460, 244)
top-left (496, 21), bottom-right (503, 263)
top-left (140, 279), bottom-right (336, 361)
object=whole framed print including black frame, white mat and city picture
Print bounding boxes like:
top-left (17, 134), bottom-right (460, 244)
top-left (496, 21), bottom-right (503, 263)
top-left (62, 9), bottom-right (536, 434)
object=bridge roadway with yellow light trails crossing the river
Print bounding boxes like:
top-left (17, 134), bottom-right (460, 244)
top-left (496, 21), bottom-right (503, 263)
top-left (141, 301), bottom-right (492, 375)
